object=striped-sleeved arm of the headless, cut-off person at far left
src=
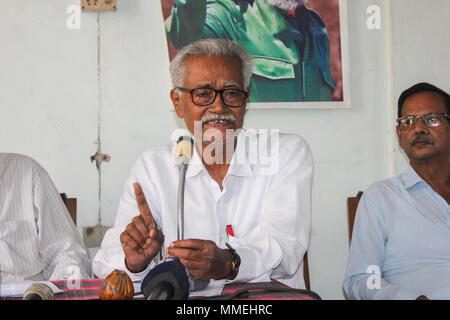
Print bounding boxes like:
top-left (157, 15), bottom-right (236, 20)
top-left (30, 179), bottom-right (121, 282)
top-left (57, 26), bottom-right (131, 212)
top-left (33, 169), bottom-right (91, 280)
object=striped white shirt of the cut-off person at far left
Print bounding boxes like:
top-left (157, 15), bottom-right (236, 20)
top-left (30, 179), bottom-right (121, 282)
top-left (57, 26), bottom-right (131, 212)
top-left (0, 153), bottom-right (90, 282)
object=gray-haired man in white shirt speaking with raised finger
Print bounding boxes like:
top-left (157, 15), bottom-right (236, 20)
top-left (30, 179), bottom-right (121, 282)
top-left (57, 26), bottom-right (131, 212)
top-left (93, 39), bottom-right (313, 288)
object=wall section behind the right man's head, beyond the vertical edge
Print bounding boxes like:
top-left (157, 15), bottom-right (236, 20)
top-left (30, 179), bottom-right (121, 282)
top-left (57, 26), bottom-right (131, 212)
top-left (392, 0), bottom-right (450, 173)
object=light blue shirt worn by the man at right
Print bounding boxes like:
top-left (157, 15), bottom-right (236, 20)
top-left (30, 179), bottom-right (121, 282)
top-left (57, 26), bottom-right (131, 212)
top-left (344, 167), bottom-right (450, 300)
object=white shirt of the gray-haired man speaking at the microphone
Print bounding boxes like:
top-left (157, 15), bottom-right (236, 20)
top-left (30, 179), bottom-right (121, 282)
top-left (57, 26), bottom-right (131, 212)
top-left (93, 130), bottom-right (313, 288)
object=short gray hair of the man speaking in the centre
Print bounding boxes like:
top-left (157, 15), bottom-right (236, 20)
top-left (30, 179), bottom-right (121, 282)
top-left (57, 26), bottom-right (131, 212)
top-left (170, 39), bottom-right (253, 89)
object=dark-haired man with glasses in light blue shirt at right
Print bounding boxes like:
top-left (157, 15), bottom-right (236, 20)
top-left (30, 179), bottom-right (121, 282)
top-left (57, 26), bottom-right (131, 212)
top-left (344, 83), bottom-right (450, 299)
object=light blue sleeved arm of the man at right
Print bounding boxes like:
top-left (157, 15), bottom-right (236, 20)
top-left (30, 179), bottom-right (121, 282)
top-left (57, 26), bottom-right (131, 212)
top-left (344, 190), bottom-right (421, 300)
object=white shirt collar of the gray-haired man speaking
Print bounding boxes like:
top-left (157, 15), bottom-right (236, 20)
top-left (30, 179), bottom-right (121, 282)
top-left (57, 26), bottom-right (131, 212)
top-left (181, 129), bottom-right (253, 178)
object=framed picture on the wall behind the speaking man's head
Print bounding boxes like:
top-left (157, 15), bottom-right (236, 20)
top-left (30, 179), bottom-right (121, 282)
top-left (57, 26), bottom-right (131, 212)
top-left (161, 0), bottom-right (351, 109)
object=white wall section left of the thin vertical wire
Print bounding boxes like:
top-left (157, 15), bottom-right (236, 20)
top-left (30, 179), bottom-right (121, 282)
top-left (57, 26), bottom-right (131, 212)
top-left (0, 0), bottom-right (98, 231)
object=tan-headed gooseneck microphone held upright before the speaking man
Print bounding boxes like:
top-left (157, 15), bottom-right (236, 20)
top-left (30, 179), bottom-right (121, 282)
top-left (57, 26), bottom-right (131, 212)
top-left (175, 136), bottom-right (209, 291)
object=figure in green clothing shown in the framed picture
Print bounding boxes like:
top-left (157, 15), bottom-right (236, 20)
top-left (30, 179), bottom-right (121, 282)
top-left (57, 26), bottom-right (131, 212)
top-left (165, 0), bottom-right (335, 102)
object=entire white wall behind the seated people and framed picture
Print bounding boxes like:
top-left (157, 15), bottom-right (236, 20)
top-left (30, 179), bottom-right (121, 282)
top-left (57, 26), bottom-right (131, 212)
top-left (0, 0), bottom-right (449, 299)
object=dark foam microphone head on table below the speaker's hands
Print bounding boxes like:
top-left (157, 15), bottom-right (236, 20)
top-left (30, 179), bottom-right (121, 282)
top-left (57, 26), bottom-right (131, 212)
top-left (141, 257), bottom-right (189, 300)
